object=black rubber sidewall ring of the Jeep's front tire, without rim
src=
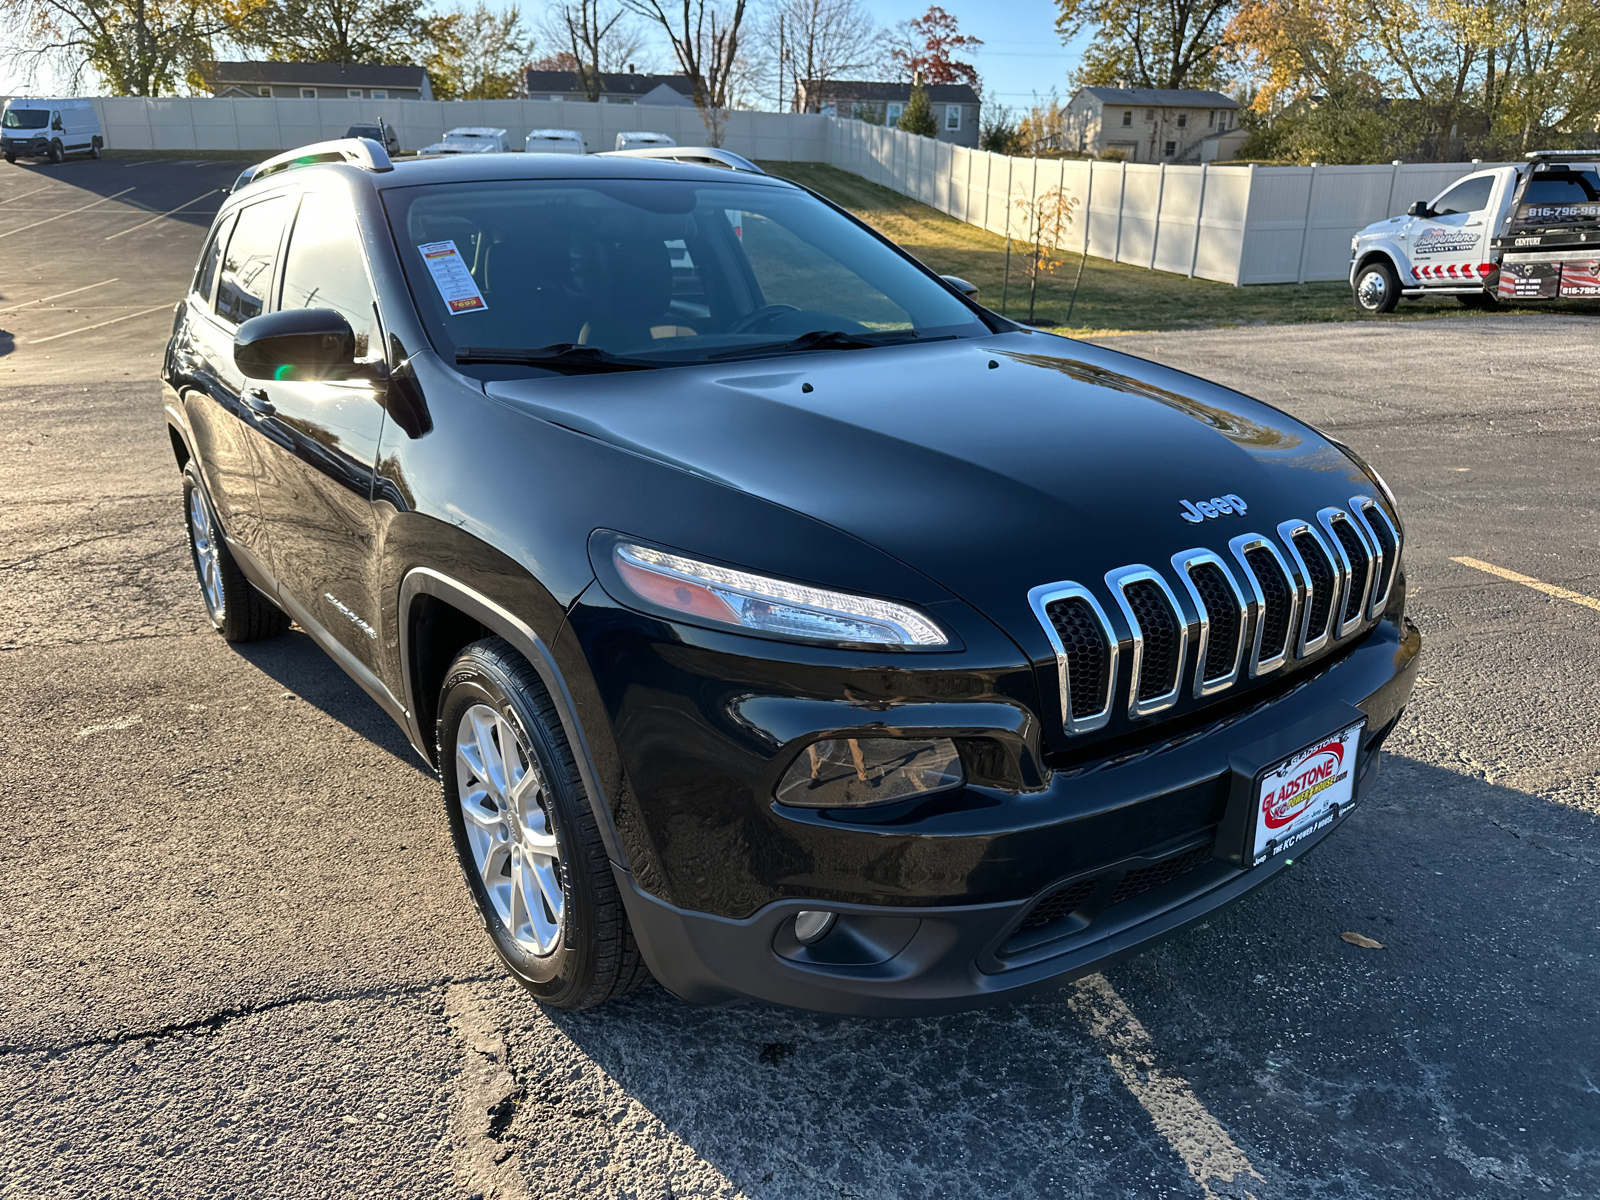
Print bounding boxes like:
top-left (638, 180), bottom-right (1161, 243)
top-left (435, 662), bottom-right (595, 1003)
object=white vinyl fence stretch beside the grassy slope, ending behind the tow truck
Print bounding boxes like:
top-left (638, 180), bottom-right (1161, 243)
top-left (827, 122), bottom-right (1510, 283)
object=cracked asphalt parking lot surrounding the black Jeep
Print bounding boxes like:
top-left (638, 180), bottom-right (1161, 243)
top-left (0, 160), bottom-right (1600, 1200)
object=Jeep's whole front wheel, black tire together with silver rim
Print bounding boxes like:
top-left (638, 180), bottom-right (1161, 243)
top-left (435, 638), bottom-right (650, 1010)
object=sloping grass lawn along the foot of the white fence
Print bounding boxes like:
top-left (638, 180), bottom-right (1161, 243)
top-left (762, 163), bottom-right (1592, 336)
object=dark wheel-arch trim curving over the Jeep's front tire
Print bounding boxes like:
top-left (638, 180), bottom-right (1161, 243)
top-left (398, 566), bottom-right (629, 870)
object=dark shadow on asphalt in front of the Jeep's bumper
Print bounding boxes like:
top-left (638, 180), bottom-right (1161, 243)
top-left (533, 755), bottom-right (1600, 1200)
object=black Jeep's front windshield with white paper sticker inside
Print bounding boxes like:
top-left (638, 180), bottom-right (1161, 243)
top-left (384, 179), bottom-right (990, 376)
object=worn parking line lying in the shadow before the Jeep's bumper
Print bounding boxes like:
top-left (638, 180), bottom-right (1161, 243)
top-left (1067, 974), bottom-right (1264, 1198)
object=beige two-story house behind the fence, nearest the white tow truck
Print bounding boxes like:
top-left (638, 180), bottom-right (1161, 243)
top-left (1066, 88), bottom-right (1238, 163)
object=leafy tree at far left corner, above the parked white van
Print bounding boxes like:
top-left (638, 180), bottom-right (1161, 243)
top-left (0, 0), bottom-right (230, 96)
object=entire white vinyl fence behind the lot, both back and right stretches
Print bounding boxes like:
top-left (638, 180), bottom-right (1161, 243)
top-left (84, 96), bottom-right (1480, 285)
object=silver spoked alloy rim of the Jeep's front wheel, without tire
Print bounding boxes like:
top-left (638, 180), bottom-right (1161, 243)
top-left (456, 704), bottom-right (566, 955)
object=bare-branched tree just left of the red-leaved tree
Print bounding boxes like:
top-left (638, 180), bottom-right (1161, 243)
top-left (752, 0), bottom-right (886, 115)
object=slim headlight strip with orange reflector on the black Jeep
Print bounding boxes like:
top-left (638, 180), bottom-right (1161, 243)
top-left (613, 542), bottom-right (950, 650)
